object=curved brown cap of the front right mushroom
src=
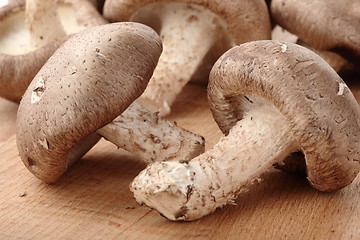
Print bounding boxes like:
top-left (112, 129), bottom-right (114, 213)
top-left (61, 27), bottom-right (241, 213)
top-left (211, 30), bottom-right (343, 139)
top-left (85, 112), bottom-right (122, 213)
top-left (208, 40), bottom-right (360, 191)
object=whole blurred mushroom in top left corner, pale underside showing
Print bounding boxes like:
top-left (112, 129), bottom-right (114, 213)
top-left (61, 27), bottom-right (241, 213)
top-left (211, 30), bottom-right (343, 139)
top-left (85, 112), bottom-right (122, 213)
top-left (0, 0), bottom-right (106, 102)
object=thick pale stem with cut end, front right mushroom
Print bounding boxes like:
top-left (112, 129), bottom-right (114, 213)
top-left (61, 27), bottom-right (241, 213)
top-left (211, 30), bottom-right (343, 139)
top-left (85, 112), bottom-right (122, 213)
top-left (130, 106), bottom-right (298, 221)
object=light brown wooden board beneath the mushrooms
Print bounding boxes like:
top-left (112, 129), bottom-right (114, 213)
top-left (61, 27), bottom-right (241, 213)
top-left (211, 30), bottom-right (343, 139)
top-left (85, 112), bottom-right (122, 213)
top-left (0, 84), bottom-right (360, 240)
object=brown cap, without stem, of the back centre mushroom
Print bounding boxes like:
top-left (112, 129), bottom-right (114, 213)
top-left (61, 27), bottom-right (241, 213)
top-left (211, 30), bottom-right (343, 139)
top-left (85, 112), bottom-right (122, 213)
top-left (103, 0), bottom-right (271, 44)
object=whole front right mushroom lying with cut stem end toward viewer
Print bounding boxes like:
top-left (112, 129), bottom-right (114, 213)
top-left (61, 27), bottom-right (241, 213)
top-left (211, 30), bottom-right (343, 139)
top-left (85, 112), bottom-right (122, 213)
top-left (131, 40), bottom-right (360, 221)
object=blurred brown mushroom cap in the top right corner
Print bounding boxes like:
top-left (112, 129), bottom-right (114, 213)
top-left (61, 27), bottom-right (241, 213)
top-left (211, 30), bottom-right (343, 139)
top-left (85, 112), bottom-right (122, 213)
top-left (271, 0), bottom-right (360, 56)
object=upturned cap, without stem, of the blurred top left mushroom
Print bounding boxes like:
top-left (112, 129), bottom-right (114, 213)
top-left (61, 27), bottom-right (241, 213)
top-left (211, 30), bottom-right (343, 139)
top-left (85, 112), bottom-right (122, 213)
top-left (0, 0), bottom-right (106, 102)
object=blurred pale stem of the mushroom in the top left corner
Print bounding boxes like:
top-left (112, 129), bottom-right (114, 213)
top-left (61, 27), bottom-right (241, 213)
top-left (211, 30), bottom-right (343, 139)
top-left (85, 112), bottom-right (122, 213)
top-left (25, 0), bottom-right (66, 48)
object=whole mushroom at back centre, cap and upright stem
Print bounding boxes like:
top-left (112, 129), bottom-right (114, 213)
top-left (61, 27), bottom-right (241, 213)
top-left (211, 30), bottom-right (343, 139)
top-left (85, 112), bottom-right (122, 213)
top-left (104, 0), bottom-right (271, 115)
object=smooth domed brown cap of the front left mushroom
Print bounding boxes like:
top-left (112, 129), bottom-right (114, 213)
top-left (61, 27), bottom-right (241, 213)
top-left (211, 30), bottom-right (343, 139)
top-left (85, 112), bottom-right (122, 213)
top-left (16, 23), bottom-right (162, 182)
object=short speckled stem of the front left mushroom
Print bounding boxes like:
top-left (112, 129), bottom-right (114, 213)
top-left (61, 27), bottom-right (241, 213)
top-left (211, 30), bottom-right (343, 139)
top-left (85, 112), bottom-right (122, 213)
top-left (97, 102), bottom-right (204, 163)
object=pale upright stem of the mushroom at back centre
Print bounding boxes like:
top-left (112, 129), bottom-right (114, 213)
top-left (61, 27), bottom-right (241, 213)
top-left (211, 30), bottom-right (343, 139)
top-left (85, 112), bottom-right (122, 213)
top-left (133, 3), bottom-right (226, 115)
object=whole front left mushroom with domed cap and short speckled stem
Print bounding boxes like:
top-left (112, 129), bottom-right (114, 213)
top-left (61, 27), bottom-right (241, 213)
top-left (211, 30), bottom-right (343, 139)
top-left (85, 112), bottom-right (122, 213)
top-left (16, 23), bottom-right (204, 182)
